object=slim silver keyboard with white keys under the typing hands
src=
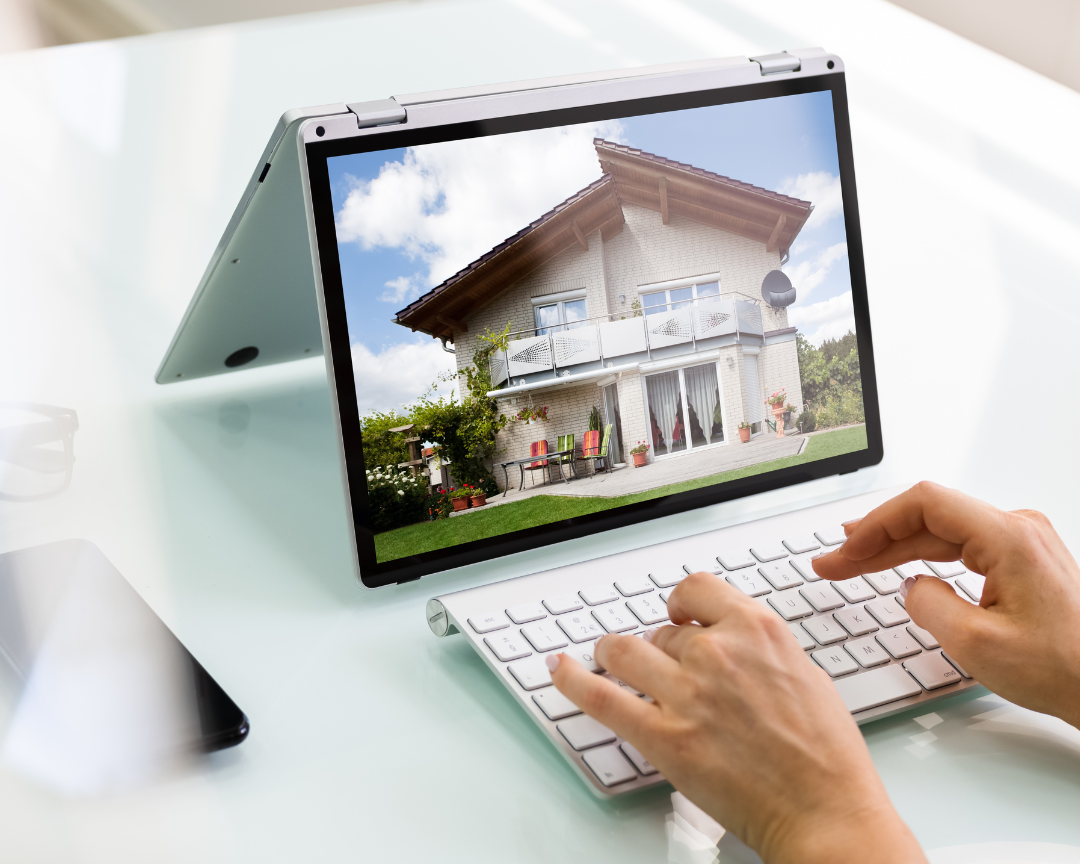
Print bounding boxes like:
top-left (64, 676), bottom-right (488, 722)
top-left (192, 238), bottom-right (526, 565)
top-left (427, 489), bottom-right (983, 797)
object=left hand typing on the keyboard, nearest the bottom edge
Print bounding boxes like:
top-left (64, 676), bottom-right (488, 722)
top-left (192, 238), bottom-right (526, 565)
top-left (552, 572), bottom-right (924, 864)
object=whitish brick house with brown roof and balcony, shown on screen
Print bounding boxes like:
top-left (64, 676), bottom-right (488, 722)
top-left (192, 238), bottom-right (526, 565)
top-left (395, 138), bottom-right (813, 480)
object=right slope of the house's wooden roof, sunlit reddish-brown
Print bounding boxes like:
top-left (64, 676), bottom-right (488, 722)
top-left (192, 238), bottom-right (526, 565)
top-left (593, 138), bottom-right (813, 253)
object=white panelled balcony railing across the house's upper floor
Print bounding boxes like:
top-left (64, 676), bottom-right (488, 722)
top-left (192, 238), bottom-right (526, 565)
top-left (490, 295), bottom-right (765, 387)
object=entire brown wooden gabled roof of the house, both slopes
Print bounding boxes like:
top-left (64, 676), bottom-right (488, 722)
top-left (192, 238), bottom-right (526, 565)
top-left (396, 138), bottom-right (813, 339)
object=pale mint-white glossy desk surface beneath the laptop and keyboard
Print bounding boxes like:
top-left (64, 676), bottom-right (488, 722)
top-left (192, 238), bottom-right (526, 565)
top-left (0, 0), bottom-right (1080, 864)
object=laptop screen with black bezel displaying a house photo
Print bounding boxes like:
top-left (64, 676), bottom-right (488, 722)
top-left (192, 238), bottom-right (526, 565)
top-left (308, 77), bottom-right (880, 583)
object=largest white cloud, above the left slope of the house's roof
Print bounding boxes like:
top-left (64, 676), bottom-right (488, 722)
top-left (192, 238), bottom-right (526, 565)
top-left (337, 121), bottom-right (623, 288)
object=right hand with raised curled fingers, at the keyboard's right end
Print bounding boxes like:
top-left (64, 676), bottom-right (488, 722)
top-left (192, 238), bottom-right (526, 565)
top-left (813, 483), bottom-right (1080, 728)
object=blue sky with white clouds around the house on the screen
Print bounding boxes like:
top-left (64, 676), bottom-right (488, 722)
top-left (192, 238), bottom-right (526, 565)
top-left (328, 93), bottom-right (854, 413)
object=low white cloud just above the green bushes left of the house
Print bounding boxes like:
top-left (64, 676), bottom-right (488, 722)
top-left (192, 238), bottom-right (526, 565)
top-left (352, 339), bottom-right (456, 414)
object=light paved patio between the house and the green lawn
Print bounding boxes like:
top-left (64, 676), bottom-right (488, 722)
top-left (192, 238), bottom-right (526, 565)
top-left (454, 433), bottom-right (808, 516)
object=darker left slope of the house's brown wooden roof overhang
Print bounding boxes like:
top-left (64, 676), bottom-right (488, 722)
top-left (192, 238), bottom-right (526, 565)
top-left (395, 175), bottom-right (624, 339)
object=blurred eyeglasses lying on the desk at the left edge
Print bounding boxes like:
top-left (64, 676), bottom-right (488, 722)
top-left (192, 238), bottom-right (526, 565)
top-left (0, 402), bottom-right (79, 502)
